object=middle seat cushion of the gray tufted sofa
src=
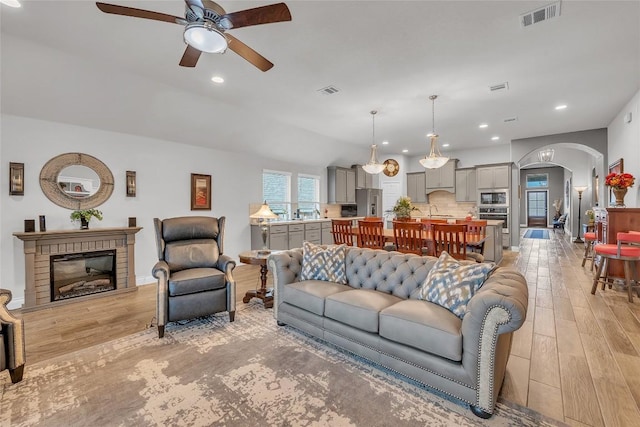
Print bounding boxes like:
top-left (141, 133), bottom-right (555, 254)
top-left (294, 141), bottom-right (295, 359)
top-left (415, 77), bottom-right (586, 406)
top-left (324, 289), bottom-right (402, 333)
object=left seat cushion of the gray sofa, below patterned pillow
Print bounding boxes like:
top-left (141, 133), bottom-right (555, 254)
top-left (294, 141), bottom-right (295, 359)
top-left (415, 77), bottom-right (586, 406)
top-left (282, 280), bottom-right (352, 316)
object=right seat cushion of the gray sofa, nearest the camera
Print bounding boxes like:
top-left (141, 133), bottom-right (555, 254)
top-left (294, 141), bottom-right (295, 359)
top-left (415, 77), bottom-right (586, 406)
top-left (380, 300), bottom-right (462, 362)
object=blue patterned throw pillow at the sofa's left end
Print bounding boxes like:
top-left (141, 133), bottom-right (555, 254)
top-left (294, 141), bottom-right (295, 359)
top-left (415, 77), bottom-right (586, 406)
top-left (300, 242), bottom-right (347, 285)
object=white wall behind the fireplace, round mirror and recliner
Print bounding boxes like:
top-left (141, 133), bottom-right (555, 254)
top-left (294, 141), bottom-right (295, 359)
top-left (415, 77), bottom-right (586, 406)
top-left (0, 115), bottom-right (350, 308)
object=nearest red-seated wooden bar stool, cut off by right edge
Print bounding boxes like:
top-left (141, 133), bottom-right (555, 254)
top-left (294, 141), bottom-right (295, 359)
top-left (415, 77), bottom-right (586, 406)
top-left (591, 231), bottom-right (640, 302)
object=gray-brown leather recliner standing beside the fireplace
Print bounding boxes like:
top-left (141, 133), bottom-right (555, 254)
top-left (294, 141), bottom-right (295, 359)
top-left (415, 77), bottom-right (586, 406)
top-left (153, 216), bottom-right (236, 338)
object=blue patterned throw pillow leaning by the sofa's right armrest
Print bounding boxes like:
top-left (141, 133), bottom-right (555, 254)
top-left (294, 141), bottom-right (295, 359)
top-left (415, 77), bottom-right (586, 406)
top-left (419, 252), bottom-right (496, 319)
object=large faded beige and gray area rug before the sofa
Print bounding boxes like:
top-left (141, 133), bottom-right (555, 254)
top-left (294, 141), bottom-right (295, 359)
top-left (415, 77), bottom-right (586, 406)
top-left (0, 302), bottom-right (557, 426)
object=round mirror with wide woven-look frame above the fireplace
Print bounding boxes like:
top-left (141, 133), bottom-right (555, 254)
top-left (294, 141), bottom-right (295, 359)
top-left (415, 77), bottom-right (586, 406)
top-left (40, 153), bottom-right (113, 210)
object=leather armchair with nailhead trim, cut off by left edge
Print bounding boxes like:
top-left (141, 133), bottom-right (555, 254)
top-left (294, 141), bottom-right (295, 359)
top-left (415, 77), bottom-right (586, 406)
top-left (0, 289), bottom-right (25, 383)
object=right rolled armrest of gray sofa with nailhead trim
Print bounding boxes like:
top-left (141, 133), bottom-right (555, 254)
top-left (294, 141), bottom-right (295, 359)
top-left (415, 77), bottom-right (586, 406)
top-left (462, 268), bottom-right (529, 413)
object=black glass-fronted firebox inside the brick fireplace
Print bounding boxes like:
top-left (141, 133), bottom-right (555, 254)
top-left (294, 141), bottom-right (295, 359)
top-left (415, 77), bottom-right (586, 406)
top-left (49, 250), bottom-right (116, 302)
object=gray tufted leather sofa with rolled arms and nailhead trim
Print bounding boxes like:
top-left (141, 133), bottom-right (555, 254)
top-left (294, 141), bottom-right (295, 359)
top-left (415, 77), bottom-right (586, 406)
top-left (268, 247), bottom-right (528, 418)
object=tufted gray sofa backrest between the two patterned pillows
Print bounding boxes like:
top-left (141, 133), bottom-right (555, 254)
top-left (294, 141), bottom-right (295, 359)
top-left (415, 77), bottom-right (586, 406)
top-left (346, 247), bottom-right (438, 299)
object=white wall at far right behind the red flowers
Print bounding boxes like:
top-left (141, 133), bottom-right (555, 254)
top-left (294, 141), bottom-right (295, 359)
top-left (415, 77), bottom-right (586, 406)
top-left (607, 91), bottom-right (640, 207)
